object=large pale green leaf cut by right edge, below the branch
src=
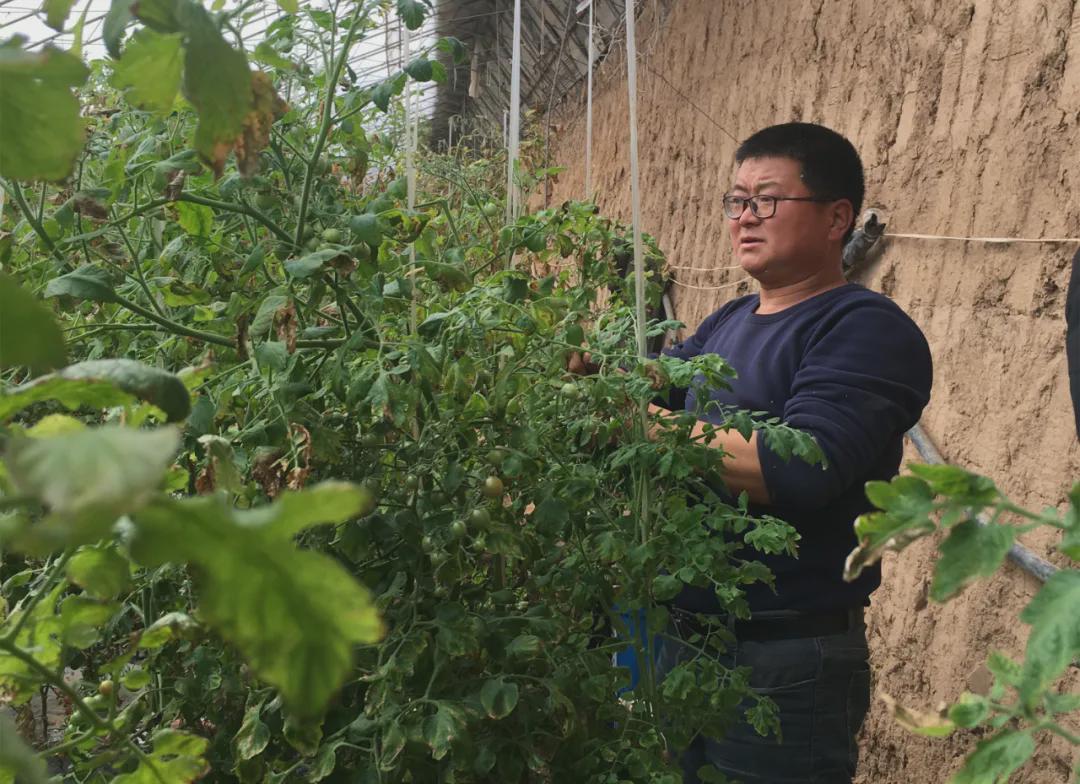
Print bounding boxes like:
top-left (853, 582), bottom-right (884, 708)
top-left (1020, 569), bottom-right (1080, 705)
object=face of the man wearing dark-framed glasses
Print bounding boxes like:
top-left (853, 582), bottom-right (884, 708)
top-left (728, 158), bottom-right (851, 285)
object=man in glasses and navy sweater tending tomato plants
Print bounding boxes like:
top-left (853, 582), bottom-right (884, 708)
top-left (591, 123), bottom-right (931, 784)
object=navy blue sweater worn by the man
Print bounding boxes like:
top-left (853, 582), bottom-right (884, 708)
top-left (664, 283), bottom-right (932, 612)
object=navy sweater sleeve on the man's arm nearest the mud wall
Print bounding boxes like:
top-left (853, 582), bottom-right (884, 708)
top-left (758, 303), bottom-right (932, 509)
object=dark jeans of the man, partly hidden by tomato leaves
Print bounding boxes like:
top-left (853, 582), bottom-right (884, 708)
top-left (657, 613), bottom-right (870, 784)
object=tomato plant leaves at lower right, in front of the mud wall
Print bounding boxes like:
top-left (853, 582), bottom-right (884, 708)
top-left (846, 464), bottom-right (1080, 784)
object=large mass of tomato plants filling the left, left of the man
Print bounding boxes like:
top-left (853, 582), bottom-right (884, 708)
top-left (0, 0), bottom-right (818, 782)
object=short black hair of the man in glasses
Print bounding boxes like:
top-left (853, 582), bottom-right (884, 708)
top-left (735, 122), bottom-right (866, 242)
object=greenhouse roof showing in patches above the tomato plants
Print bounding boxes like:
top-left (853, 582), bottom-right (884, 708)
top-left (0, 0), bottom-right (640, 145)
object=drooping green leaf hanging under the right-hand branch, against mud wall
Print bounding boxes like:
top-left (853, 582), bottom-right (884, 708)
top-left (930, 519), bottom-right (1016, 601)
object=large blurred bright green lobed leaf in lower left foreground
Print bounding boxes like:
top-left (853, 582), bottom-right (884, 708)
top-left (132, 491), bottom-right (382, 718)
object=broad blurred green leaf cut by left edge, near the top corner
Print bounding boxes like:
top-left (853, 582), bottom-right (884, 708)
top-left (0, 38), bottom-right (90, 180)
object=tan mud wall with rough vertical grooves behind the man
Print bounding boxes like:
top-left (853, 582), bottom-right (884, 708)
top-left (540, 0), bottom-right (1080, 784)
